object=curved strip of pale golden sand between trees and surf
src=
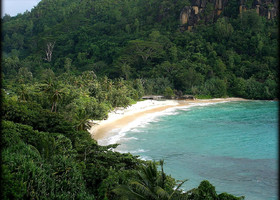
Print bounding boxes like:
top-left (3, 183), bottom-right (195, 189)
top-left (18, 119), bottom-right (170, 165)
top-left (88, 98), bottom-right (248, 142)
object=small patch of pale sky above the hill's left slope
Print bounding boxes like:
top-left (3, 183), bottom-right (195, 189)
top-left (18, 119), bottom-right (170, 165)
top-left (2, 0), bottom-right (40, 17)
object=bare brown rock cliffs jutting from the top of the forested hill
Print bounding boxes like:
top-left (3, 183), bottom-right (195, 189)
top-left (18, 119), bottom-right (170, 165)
top-left (180, 0), bottom-right (279, 31)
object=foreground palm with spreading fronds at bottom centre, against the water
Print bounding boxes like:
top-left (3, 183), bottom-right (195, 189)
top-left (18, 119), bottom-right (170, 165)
top-left (113, 160), bottom-right (187, 200)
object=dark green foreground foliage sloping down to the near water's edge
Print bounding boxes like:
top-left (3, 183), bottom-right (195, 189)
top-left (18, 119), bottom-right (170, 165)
top-left (1, 95), bottom-right (243, 200)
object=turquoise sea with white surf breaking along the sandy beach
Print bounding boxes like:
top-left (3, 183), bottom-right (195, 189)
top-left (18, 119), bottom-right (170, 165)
top-left (99, 100), bottom-right (278, 200)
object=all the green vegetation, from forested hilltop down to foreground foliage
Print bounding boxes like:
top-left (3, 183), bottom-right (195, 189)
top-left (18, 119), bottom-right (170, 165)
top-left (1, 0), bottom-right (278, 200)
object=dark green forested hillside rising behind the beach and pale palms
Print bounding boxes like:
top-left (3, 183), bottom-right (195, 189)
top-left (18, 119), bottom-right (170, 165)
top-left (2, 0), bottom-right (278, 99)
